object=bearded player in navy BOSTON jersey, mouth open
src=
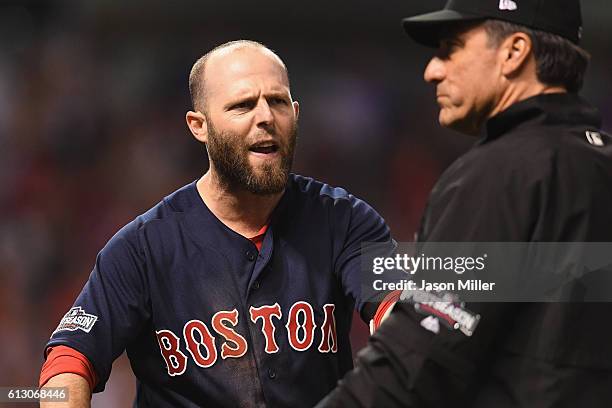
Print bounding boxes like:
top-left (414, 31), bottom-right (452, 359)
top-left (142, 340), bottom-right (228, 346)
top-left (40, 41), bottom-right (392, 407)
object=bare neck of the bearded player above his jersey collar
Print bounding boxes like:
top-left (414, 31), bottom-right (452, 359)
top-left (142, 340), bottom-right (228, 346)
top-left (196, 171), bottom-right (283, 238)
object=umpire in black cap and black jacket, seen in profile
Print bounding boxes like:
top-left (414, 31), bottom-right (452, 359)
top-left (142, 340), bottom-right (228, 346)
top-left (319, 0), bottom-right (612, 408)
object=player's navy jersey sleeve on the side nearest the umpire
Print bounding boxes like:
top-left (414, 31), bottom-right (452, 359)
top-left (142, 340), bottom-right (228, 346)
top-left (335, 195), bottom-right (396, 323)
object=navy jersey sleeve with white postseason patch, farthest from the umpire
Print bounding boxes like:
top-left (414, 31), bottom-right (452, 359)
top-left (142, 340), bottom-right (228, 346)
top-left (45, 224), bottom-right (150, 392)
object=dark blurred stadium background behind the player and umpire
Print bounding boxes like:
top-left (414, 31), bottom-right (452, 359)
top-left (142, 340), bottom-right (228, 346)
top-left (0, 0), bottom-right (612, 407)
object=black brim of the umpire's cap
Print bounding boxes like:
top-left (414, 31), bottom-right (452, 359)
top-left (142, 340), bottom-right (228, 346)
top-left (402, 9), bottom-right (483, 48)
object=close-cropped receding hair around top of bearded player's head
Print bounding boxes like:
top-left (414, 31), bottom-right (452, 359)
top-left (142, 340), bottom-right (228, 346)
top-left (189, 40), bottom-right (289, 112)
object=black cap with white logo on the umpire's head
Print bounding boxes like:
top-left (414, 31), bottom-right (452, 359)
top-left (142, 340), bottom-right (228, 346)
top-left (402, 0), bottom-right (582, 47)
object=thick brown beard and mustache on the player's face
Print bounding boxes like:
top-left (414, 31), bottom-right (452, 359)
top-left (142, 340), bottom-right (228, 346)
top-left (206, 121), bottom-right (297, 195)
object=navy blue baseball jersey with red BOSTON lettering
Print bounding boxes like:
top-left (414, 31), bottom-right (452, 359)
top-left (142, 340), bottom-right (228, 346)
top-left (47, 175), bottom-right (391, 407)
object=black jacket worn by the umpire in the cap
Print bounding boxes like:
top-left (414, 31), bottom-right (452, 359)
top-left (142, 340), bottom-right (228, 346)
top-left (320, 94), bottom-right (612, 408)
